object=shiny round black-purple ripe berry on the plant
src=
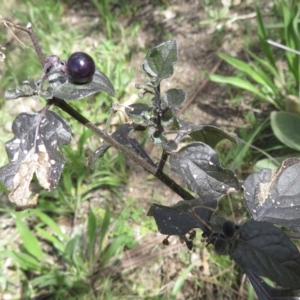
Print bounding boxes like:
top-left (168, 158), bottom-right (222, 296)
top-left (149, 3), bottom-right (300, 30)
top-left (67, 52), bottom-right (95, 83)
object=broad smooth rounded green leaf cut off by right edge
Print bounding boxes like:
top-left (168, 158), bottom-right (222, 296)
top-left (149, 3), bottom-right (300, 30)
top-left (271, 111), bottom-right (300, 151)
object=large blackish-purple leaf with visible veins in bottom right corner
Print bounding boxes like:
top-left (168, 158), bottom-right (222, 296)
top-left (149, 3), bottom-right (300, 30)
top-left (230, 221), bottom-right (300, 289)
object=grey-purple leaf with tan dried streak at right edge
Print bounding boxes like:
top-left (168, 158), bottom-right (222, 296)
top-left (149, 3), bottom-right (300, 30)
top-left (244, 158), bottom-right (300, 231)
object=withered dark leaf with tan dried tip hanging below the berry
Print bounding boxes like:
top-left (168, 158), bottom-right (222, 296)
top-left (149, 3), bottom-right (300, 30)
top-left (0, 111), bottom-right (71, 210)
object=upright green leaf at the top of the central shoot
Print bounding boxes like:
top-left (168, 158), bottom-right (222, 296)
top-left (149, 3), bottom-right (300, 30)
top-left (142, 40), bottom-right (178, 86)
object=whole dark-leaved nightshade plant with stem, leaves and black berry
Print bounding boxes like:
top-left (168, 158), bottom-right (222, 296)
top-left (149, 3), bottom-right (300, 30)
top-left (0, 24), bottom-right (300, 300)
